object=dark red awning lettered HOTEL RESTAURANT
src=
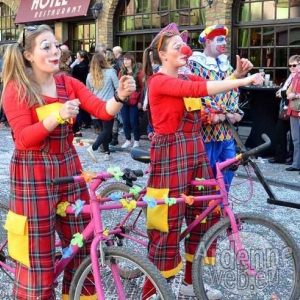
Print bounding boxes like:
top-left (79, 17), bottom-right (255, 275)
top-left (15, 0), bottom-right (90, 24)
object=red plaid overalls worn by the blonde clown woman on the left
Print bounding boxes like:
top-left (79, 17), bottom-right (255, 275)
top-left (9, 77), bottom-right (90, 300)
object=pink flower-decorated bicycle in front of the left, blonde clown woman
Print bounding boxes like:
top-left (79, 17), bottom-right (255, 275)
top-left (0, 172), bottom-right (175, 300)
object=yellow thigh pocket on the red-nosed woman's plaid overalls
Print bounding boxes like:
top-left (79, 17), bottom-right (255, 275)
top-left (146, 187), bottom-right (170, 232)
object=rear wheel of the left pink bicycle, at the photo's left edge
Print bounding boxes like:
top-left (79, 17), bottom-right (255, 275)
top-left (0, 203), bottom-right (15, 299)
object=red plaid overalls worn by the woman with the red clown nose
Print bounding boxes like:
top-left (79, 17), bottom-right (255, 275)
top-left (148, 106), bottom-right (219, 277)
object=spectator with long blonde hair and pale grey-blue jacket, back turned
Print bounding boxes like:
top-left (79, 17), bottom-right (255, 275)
top-left (86, 53), bottom-right (119, 162)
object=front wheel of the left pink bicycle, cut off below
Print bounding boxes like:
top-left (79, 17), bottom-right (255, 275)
top-left (69, 246), bottom-right (175, 300)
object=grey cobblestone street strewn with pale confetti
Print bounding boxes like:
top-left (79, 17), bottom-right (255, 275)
top-left (0, 127), bottom-right (300, 300)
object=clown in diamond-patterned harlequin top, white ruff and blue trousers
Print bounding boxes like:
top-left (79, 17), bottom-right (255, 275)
top-left (189, 25), bottom-right (243, 190)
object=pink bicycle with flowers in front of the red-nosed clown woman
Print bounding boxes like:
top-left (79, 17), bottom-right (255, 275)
top-left (96, 135), bottom-right (300, 300)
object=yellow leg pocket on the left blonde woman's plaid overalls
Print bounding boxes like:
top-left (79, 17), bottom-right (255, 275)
top-left (4, 210), bottom-right (30, 267)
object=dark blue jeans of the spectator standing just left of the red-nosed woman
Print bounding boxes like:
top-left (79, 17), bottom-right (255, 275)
top-left (121, 104), bottom-right (140, 141)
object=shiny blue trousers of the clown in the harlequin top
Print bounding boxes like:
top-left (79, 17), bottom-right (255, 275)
top-left (204, 139), bottom-right (236, 192)
